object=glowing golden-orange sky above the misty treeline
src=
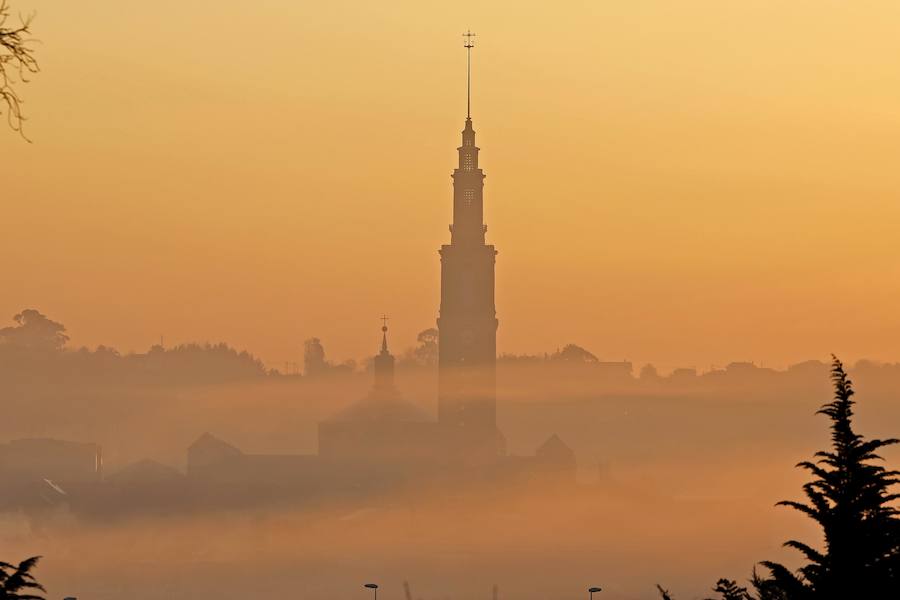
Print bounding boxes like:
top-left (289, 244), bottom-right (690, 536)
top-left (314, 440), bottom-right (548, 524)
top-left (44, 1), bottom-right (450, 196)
top-left (0, 0), bottom-right (900, 368)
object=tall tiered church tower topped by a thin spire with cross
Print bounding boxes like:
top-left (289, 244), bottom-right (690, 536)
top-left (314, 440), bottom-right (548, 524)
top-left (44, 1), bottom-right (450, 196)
top-left (437, 33), bottom-right (499, 454)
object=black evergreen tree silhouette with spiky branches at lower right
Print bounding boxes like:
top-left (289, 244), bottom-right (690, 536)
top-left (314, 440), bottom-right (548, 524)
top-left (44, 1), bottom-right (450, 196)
top-left (754, 356), bottom-right (900, 600)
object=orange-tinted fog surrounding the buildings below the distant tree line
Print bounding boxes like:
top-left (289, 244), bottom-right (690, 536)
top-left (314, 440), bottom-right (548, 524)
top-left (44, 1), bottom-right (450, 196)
top-left (0, 370), bottom-right (900, 600)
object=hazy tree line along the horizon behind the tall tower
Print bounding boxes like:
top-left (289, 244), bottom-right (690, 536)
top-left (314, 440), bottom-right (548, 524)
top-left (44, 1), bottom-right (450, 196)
top-left (8, 309), bottom-right (900, 393)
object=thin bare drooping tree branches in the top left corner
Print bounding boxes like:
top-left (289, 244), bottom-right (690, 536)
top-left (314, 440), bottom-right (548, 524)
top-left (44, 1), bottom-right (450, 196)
top-left (0, 0), bottom-right (40, 141)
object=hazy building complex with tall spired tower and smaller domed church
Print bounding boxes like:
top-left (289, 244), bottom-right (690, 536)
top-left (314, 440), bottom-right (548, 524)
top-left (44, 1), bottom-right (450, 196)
top-left (0, 43), bottom-right (576, 514)
